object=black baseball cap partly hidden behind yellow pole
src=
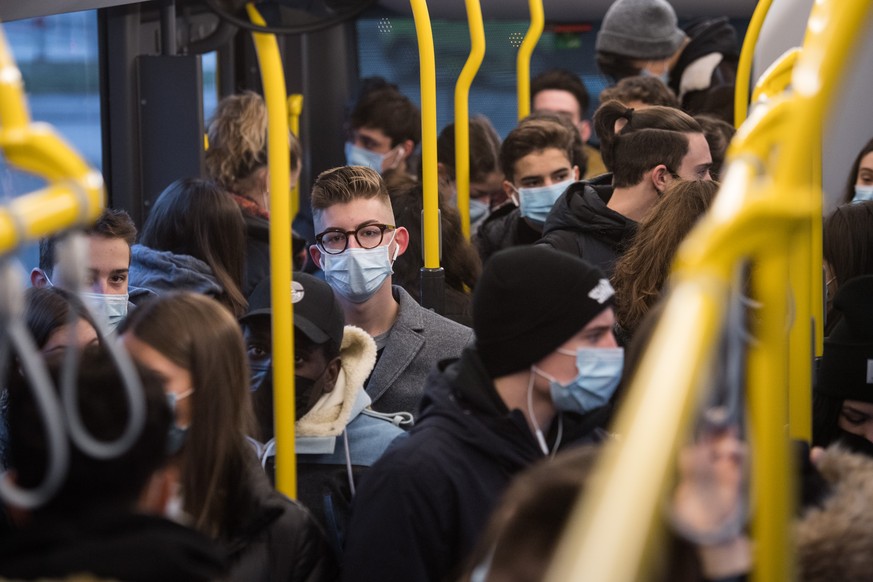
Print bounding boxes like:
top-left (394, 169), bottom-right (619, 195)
top-left (240, 272), bottom-right (345, 346)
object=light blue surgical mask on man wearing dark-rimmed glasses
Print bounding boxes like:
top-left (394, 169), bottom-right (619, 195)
top-left (321, 230), bottom-right (400, 303)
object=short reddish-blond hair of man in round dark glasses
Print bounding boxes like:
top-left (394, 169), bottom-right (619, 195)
top-left (310, 166), bottom-right (393, 221)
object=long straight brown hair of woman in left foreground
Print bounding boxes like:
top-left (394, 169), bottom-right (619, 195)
top-left (124, 292), bottom-right (254, 539)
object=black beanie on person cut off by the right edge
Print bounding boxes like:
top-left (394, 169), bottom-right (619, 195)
top-left (816, 275), bottom-right (873, 402)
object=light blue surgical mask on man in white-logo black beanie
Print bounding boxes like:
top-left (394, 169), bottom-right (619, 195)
top-left (536, 348), bottom-right (624, 414)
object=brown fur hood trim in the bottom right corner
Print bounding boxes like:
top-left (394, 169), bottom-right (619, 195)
top-left (795, 446), bottom-right (873, 582)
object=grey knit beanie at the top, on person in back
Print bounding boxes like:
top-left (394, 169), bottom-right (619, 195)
top-left (595, 0), bottom-right (685, 60)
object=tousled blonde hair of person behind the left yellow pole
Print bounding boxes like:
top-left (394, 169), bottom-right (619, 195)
top-left (206, 91), bottom-right (302, 194)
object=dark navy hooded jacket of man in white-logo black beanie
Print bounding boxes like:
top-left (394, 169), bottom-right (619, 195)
top-left (344, 349), bottom-right (543, 581)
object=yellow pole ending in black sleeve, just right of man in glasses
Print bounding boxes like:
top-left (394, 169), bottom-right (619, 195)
top-left (410, 0), bottom-right (440, 269)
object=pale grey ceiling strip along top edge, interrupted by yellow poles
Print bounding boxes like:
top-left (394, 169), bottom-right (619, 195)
top-left (379, 0), bottom-right (757, 22)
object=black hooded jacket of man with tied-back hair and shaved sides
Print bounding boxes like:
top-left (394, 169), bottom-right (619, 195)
top-left (537, 174), bottom-right (637, 277)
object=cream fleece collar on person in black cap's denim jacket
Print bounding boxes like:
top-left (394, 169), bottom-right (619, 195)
top-left (297, 325), bottom-right (376, 437)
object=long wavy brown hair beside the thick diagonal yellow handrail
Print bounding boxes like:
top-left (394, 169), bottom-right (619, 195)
top-left (612, 180), bottom-right (718, 335)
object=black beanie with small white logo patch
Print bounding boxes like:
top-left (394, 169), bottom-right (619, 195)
top-left (473, 245), bottom-right (614, 378)
